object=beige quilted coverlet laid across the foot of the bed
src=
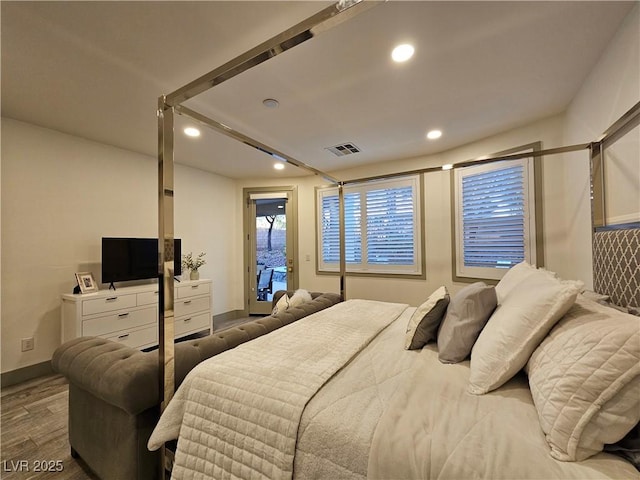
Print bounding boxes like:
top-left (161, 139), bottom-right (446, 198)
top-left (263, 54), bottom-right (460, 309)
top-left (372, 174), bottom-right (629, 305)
top-left (149, 300), bottom-right (407, 479)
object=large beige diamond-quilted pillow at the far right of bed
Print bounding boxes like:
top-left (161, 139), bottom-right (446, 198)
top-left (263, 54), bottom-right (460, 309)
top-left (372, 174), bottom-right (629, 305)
top-left (528, 295), bottom-right (640, 461)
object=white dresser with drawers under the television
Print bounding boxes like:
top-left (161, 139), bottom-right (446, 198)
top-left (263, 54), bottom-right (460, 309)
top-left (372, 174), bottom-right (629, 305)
top-left (62, 280), bottom-right (213, 349)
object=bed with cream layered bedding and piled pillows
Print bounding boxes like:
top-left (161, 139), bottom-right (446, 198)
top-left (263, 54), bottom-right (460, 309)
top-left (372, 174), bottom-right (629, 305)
top-left (149, 232), bottom-right (640, 479)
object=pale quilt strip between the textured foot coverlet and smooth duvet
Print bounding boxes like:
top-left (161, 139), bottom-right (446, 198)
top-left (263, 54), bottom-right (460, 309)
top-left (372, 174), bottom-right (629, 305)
top-left (293, 308), bottom-right (417, 480)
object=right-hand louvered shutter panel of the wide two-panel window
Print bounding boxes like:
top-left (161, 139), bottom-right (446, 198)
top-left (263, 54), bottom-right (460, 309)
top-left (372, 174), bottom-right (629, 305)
top-left (366, 186), bottom-right (415, 265)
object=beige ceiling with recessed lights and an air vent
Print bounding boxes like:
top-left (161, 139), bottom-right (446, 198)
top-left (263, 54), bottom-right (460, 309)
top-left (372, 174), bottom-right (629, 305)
top-left (1, 1), bottom-right (637, 178)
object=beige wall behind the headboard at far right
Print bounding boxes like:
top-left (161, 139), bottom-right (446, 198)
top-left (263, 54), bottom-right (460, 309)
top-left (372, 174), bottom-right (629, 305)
top-left (563, 5), bottom-right (640, 288)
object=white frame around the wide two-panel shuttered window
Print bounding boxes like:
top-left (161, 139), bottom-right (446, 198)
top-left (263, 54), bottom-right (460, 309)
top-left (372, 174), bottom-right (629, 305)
top-left (316, 174), bottom-right (425, 278)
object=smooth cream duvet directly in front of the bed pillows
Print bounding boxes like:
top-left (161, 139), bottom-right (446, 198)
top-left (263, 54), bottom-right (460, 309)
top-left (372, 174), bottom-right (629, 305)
top-left (368, 345), bottom-right (640, 480)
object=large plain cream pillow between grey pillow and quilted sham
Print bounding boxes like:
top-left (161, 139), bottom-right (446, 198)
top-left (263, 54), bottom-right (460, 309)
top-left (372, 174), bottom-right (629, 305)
top-left (468, 267), bottom-right (582, 395)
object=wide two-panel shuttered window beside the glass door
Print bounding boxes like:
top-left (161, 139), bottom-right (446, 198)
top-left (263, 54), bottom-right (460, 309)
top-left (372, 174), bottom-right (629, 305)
top-left (317, 176), bottom-right (422, 275)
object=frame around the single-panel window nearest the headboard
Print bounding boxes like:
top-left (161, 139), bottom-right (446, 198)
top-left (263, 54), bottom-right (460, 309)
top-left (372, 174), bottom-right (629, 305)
top-left (451, 142), bottom-right (544, 284)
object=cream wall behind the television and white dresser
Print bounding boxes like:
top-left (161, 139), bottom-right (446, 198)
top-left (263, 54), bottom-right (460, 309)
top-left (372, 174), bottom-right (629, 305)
top-left (1, 119), bottom-right (241, 372)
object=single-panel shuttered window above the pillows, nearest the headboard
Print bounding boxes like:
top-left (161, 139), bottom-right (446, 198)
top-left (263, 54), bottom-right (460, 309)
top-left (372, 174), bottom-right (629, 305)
top-left (454, 150), bottom-right (537, 280)
